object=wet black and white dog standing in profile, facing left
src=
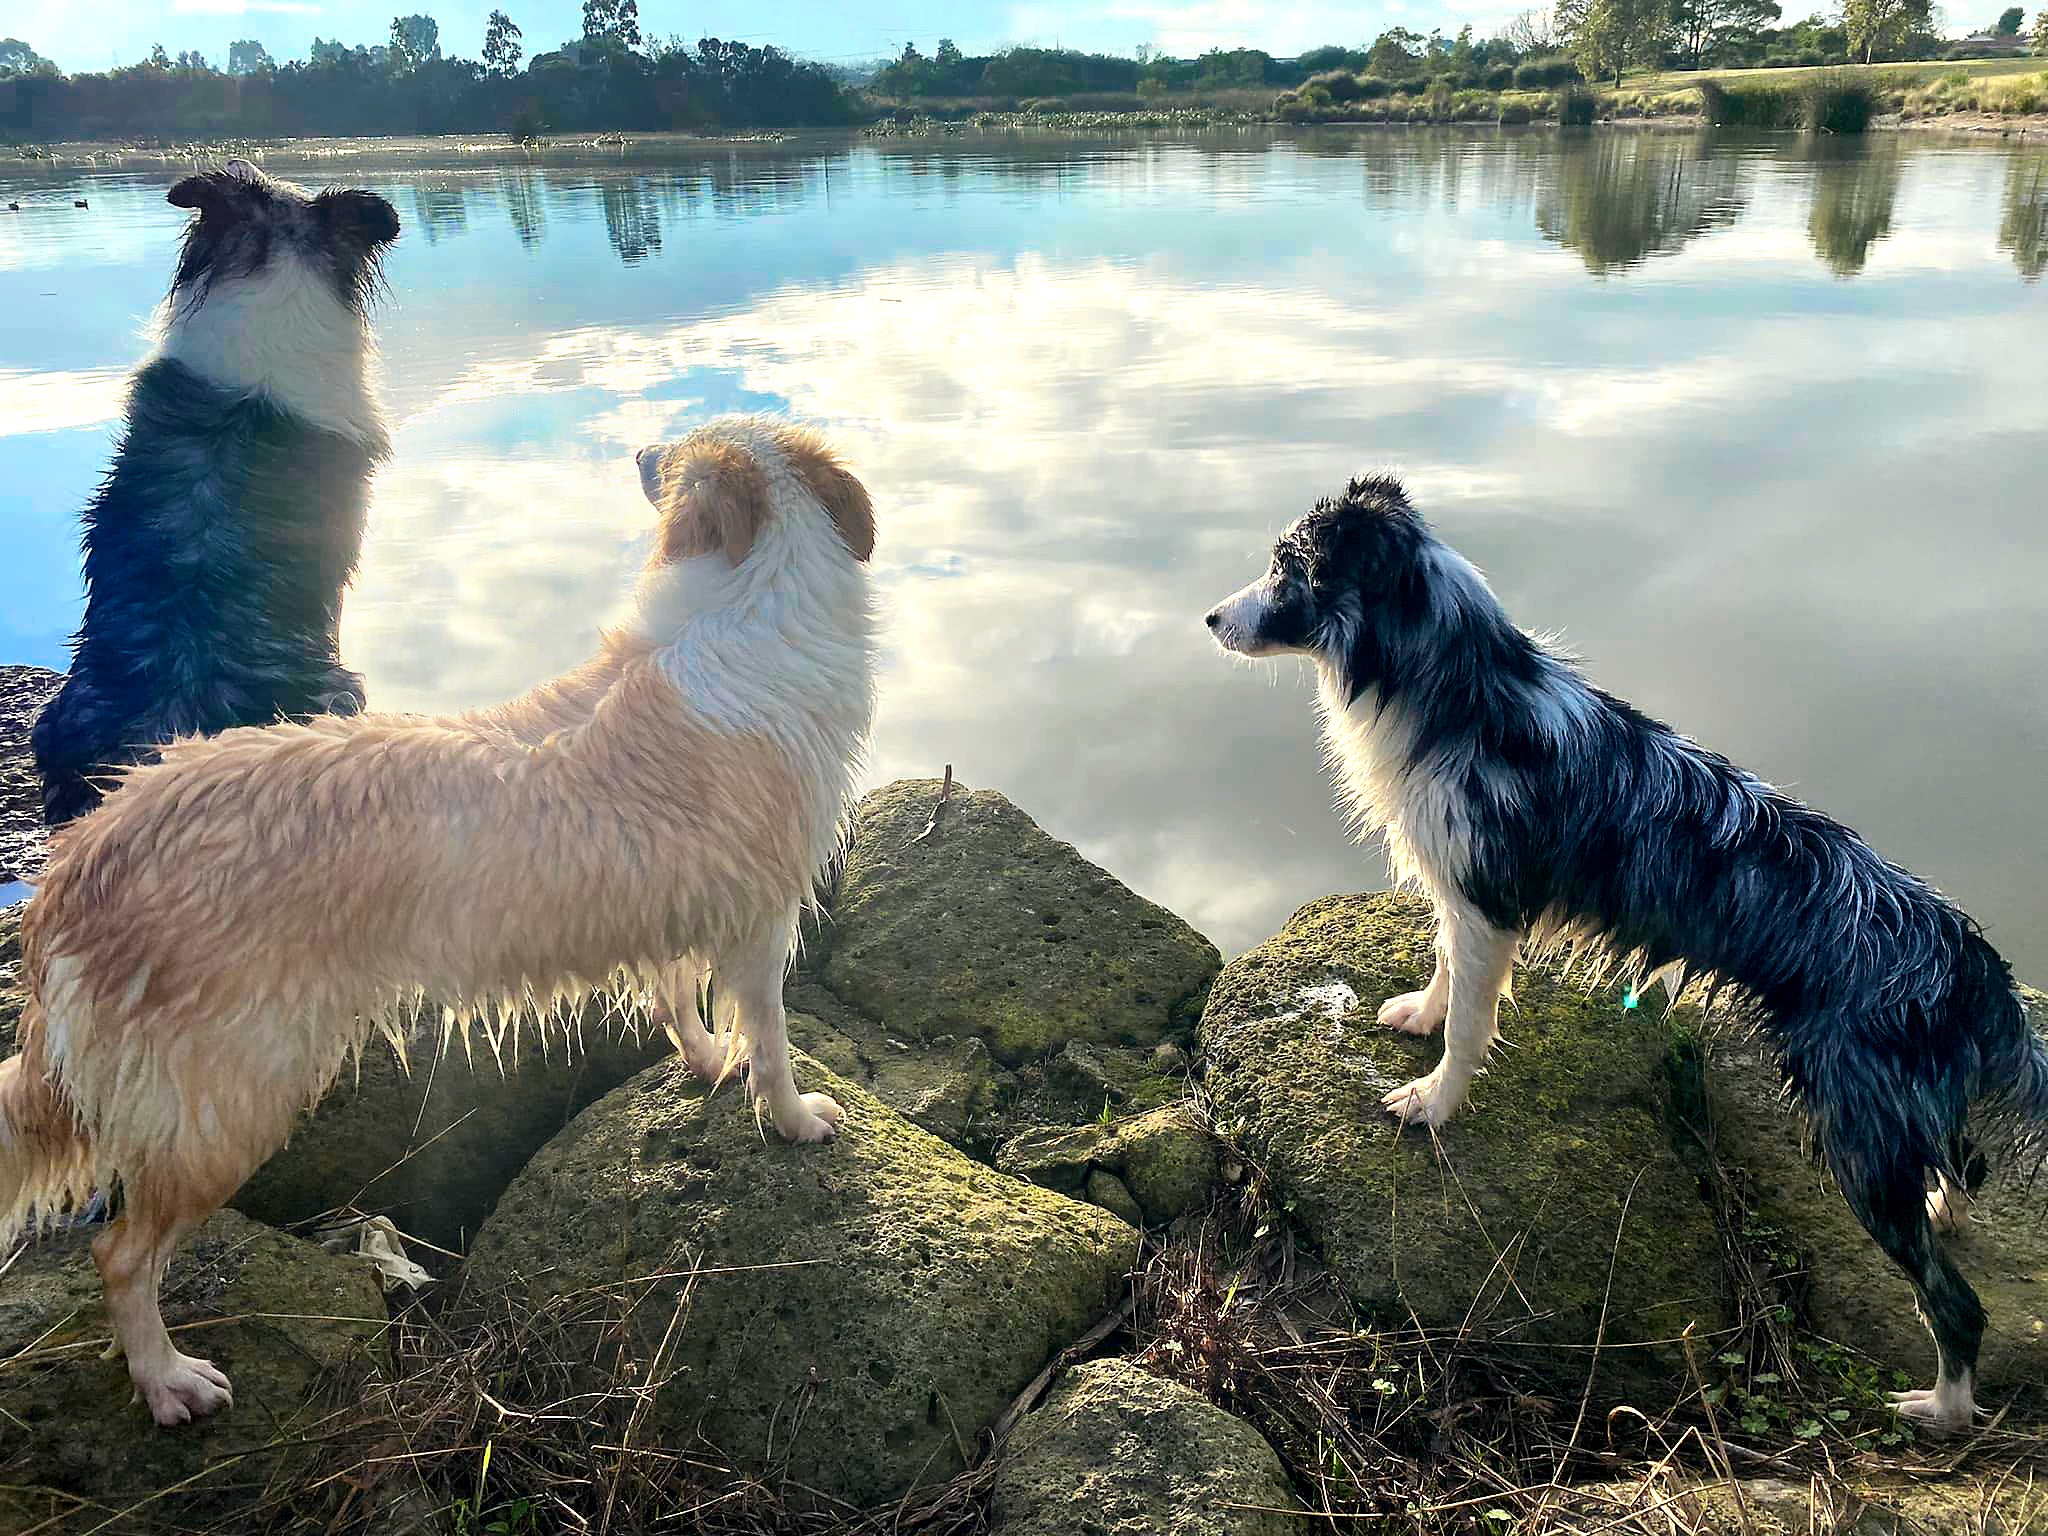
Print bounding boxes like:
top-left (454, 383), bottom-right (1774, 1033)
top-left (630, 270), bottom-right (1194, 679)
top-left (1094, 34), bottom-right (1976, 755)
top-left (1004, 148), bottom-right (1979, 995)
top-left (1208, 479), bottom-right (2048, 1432)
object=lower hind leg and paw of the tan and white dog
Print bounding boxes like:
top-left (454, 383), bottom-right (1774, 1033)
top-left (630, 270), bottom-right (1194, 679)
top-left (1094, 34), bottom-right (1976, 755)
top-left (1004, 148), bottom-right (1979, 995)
top-left (92, 1180), bottom-right (236, 1425)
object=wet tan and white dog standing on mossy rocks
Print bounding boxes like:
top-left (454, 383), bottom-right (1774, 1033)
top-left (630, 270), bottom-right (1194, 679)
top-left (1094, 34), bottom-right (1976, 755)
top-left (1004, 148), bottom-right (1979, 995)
top-left (0, 418), bottom-right (874, 1423)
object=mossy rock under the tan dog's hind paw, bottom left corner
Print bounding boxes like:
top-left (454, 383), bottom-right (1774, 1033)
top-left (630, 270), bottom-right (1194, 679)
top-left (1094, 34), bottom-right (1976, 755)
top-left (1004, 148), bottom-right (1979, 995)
top-left (0, 1210), bottom-right (387, 1536)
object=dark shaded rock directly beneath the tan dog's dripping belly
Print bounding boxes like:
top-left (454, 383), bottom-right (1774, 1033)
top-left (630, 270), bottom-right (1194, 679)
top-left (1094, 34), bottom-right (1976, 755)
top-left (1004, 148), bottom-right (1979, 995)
top-left (231, 1010), bottom-right (674, 1268)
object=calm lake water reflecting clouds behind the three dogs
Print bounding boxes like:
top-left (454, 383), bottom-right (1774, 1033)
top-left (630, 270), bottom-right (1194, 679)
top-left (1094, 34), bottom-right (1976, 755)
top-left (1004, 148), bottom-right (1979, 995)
top-left (0, 129), bottom-right (2048, 981)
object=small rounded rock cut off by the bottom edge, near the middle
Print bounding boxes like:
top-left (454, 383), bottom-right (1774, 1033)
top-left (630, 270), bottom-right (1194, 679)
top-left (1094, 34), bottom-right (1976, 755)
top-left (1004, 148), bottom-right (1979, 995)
top-left (989, 1360), bottom-right (1311, 1536)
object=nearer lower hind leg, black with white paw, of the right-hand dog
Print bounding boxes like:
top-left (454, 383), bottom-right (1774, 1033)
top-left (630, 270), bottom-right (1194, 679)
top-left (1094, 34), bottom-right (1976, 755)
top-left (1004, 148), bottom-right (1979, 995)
top-left (1821, 1114), bottom-right (1985, 1436)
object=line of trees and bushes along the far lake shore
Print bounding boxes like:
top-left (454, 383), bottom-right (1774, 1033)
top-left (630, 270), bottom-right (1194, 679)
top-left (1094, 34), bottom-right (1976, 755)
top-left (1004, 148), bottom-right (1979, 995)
top-left (0, 0), bottom-right (2048, 141)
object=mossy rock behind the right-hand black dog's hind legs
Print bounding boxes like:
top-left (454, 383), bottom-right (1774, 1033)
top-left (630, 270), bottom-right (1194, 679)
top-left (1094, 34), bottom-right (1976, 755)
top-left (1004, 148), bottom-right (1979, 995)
top-left (1706, 993), bottom-right (2048, 1405)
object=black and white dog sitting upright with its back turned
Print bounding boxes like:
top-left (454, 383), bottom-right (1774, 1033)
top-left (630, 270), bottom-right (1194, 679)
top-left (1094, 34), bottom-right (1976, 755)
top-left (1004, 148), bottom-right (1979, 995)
top-left (33, 160), bottom-right (397, 825)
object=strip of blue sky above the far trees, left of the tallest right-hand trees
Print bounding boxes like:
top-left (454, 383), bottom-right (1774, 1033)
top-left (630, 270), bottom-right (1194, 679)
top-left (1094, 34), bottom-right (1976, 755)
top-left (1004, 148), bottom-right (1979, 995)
top-left (0, 0), bottom-right (1518, 72)
